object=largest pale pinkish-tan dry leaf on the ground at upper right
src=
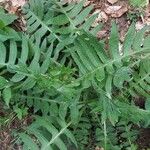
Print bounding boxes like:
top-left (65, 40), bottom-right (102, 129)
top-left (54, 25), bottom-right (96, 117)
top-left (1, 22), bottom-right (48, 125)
top-left (105, 6), bottom-right (128, 18)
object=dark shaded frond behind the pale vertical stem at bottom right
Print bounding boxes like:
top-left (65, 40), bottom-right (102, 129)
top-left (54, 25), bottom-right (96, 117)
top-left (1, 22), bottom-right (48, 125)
top-left (96, 120), bottom-right (138, 150)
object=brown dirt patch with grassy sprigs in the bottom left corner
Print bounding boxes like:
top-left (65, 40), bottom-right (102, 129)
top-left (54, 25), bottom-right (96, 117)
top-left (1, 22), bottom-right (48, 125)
top-left (0, 111), bottom-right (33, 150)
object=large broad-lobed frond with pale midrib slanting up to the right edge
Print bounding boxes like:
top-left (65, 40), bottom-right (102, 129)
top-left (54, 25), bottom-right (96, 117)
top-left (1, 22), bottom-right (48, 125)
top-left (70, 23), bottom-right (150, 95)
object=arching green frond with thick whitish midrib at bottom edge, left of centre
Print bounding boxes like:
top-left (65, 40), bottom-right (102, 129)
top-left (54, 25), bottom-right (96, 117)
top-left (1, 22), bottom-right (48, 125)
top-left (18, 117), bottom-right (77, 150)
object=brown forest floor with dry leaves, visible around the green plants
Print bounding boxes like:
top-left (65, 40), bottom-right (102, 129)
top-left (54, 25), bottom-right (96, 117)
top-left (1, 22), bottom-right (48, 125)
top-left (0, 0), bottom-right (150, 150)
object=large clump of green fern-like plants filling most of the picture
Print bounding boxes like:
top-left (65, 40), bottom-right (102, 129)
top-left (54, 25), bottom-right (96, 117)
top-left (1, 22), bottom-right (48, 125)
top-left (0, 0), bottom-right (150, 150)
